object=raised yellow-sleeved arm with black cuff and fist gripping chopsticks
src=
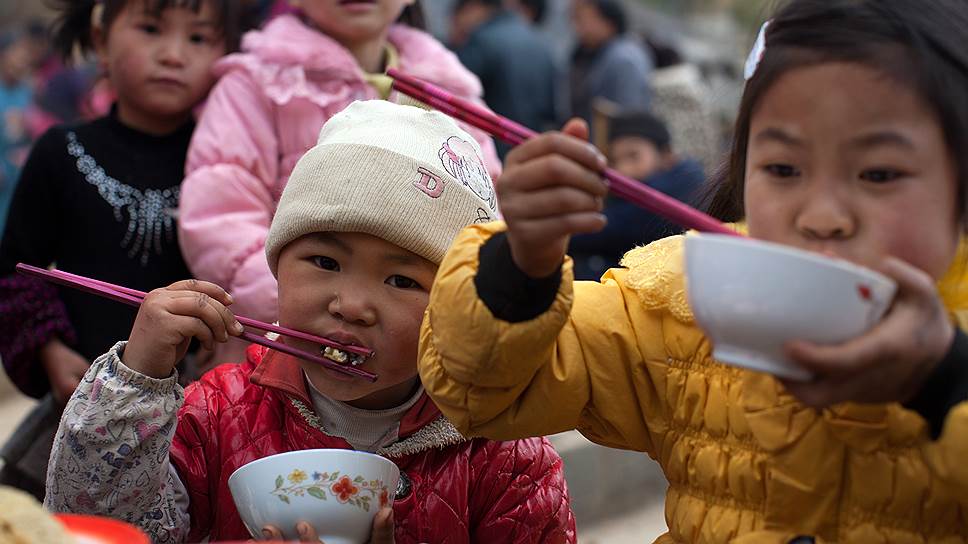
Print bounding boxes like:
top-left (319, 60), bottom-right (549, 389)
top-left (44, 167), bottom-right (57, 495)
top-left (419, 122), bottom-right (669, 452)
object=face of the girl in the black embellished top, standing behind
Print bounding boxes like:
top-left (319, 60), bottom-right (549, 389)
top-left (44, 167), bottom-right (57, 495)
top-left (98, 1), bottom-right (225, 132)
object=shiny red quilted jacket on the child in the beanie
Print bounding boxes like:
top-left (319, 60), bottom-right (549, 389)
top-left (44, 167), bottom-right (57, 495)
top-left (171, 346), bottom-right (575, 544)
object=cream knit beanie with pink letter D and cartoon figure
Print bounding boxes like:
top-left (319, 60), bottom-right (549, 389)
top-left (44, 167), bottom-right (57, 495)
top-left (266, 100), bottom-right (497, 274)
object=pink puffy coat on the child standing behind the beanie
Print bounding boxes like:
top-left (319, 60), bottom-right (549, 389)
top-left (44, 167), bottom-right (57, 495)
top-left (179, 15), bottom-right (501, 322)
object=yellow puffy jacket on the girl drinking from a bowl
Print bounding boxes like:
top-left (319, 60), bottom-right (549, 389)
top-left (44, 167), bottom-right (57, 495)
top-left (419, 223), bottom-right (968, 544)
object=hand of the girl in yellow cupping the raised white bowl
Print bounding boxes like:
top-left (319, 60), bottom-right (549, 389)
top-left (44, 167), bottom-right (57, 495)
top-left (786, 258), bottom-right (955, 408)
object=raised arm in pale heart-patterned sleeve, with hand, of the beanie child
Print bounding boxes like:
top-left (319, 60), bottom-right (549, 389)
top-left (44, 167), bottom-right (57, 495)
top-left (45, 280), bottom-right (241, 542)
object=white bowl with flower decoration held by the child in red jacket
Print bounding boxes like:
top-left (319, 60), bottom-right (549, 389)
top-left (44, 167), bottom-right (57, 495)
top-left (229, 449), bottom-right (400, 544)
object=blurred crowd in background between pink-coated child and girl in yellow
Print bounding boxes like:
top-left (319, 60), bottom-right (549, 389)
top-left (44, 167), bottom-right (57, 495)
top-left (450, 0), bottom-right (721, 279)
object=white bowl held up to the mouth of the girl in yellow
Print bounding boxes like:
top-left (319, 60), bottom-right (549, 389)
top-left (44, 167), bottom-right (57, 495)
top-left (685, 234), bottom-right (897, 381)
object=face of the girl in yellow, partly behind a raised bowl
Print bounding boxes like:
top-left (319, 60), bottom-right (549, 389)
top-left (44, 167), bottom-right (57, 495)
top-left (745, 63), bottom-right (959, 278)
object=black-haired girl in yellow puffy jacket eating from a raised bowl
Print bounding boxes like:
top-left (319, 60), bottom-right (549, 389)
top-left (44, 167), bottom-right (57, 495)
top-left (420, 0), bottom-right (968, 544)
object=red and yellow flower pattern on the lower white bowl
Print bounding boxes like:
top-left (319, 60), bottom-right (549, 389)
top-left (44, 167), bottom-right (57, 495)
top-left (271, 468), bottom-right (390, 512)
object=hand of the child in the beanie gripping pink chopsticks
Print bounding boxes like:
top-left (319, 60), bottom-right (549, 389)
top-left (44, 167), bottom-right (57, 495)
top-left (121, 280), bottom-right (242, 379)
